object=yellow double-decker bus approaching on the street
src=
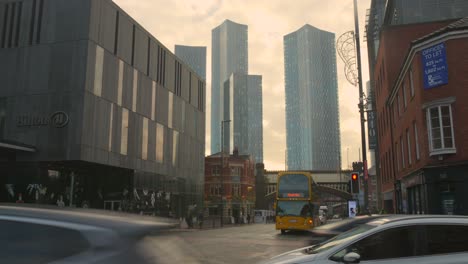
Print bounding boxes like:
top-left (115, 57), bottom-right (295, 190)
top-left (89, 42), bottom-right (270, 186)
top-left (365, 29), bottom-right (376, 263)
top-left (275, 171), bottom-right (320, 234)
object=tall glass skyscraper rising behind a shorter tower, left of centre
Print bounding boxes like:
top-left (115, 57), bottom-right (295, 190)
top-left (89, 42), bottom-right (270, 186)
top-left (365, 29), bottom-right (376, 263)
top-left (211, 20), bottom-right (248, 154)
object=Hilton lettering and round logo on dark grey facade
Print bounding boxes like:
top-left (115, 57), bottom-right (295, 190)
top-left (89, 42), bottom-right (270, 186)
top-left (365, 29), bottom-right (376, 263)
top-left (16, 111), bottom-right (69, 128)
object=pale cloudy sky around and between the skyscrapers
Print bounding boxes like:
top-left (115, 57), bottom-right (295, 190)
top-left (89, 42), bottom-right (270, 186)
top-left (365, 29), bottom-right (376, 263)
top-left (114, 0), bottom-right (370, 170)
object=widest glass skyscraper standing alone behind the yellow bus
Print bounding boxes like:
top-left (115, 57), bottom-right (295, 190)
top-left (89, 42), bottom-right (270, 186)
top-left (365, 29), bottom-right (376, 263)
top-left (284, 25), bottom-right (341, 170)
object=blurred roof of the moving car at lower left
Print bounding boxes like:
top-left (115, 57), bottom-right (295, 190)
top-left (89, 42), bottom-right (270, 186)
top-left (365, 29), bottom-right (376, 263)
top-left (0, 204), bottom-right (176, 236)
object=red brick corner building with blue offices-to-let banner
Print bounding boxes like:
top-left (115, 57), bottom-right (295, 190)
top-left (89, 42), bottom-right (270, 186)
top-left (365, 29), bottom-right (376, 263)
top-left (374, 18), bottom-right (468, 214)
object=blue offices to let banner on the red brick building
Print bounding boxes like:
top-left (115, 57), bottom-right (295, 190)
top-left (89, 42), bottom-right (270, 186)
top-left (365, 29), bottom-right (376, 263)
top-left (421, 43), bottom-right (448, 89)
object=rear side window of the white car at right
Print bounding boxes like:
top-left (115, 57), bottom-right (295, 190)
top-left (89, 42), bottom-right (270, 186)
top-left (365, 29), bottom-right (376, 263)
top-left (425, 225), bottom-right (468, 255)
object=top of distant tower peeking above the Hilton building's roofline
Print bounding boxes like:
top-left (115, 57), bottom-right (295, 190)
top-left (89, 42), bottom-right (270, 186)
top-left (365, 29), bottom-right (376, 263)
top-left (174, 45), bottom-right (206, 80)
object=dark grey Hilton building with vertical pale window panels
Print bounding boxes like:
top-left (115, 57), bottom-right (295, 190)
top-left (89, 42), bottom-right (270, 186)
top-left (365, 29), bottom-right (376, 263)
top-left (0, 0), bottom-right (205, 216)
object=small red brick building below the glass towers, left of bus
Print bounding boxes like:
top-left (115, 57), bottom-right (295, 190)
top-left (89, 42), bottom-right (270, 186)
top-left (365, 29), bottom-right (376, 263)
top-left (205, 150), bottom-right (255, 223)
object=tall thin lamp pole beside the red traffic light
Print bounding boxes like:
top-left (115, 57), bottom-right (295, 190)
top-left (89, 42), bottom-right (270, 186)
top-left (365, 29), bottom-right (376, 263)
top-left (354, 0), bottom-right (369, 210)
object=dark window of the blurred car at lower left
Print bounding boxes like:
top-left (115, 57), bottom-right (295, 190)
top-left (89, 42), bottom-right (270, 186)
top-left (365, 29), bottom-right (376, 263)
top-left (0, 220), bottom-right (89, 264)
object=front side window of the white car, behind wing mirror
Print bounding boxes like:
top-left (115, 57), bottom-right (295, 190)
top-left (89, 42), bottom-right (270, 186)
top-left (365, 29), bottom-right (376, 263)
top-left (331, 227), bottom-right (420, 261)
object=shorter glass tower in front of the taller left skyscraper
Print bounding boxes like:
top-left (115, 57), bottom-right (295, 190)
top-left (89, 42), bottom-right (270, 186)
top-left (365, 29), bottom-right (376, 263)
top-left (223, 73), bottom-right (263, 163)
